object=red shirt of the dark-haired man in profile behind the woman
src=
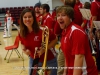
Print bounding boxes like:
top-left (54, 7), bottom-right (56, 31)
top-left (42, 13), bottom-right (55, 29)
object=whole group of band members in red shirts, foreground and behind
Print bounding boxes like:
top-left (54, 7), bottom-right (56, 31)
top-left (0, 0), bottom-right (100, 75)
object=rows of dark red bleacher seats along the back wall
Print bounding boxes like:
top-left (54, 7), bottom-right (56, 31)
top-left (0, 6), bottom-right (33, 30)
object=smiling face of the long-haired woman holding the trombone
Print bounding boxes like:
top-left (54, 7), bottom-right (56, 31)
top-left (23, 12), bottom-right (34, 28)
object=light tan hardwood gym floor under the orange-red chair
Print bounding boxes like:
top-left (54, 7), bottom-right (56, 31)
top-left (0, 31), bottom-right (100, 75)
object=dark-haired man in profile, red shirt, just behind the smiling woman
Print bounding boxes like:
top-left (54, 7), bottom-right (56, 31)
top-left (40, 4), bottom-right (55, 31)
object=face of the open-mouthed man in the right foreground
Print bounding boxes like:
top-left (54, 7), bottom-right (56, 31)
top-left (57, 11), bottom-right (71, 29)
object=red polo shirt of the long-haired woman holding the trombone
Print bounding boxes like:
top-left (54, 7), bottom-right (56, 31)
top-left (19, 30), bottom-right (56, 62)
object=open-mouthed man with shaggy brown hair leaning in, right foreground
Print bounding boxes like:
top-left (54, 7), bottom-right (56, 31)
top-left (57, 6), bottom-right (98, 75)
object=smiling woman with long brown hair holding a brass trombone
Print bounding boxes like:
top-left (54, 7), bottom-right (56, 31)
top-left (19, 8), bottom-right (57, 75)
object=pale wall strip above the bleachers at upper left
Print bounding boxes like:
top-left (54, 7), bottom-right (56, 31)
top-left (0, 0), bottom-right (39, 8)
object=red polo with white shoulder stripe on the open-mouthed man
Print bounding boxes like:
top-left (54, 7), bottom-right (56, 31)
top-left (61, 23), bottom-right (98, 75)
